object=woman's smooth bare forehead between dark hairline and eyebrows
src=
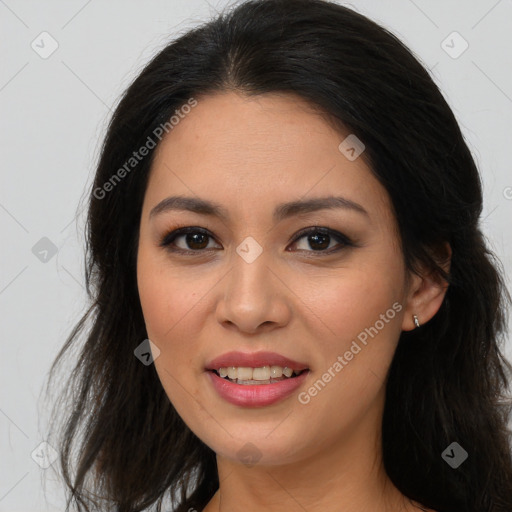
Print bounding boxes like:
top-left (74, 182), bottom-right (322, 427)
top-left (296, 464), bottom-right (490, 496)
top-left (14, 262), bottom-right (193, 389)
top-left (146, 92), bottom-right (390, 226)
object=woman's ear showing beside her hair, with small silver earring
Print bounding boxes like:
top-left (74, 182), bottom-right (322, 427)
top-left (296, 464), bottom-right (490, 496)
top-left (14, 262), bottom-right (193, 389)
top-left (402, 242), bottom-right (452, 331)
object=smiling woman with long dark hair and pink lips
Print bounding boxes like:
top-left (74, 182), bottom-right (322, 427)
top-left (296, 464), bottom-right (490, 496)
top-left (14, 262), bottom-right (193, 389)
top-left (44, 0), bottom-right (512, 512)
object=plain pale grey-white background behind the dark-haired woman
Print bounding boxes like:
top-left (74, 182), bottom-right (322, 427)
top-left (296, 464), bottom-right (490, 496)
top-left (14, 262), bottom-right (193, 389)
top-left (0, 0), bottom-right (512, 512)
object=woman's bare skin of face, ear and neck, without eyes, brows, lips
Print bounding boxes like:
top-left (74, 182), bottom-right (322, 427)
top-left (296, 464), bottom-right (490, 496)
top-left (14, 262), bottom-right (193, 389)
top-left (137, 92), bottom-right (446, 512)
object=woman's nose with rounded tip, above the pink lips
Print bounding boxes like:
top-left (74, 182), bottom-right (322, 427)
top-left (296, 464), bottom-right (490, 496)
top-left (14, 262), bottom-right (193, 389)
top-left (216, 251), bottom-right (293, 334)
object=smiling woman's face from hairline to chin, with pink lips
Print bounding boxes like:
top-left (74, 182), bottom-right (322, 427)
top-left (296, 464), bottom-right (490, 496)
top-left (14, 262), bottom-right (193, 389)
top-left (137, 92), bottom-right (416, 465)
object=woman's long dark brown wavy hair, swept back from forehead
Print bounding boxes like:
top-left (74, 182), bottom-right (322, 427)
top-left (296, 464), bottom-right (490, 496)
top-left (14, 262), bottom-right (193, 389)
top-left (44, 0), bottom-right (512, 512)
